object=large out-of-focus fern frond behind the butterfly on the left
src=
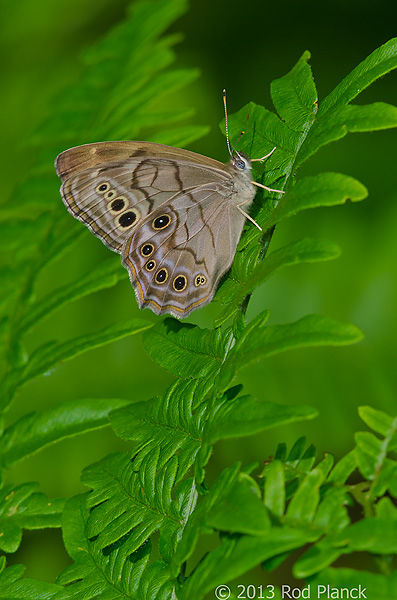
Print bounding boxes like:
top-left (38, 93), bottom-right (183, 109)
top-left (0, 0), bottom-right (207, 422)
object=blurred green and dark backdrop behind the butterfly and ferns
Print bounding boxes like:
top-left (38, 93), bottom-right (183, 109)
top-left (0, 0), bottom-right (397, 581)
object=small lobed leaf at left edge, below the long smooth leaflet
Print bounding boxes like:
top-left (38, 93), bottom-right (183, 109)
top-left (0, 483), bottom-right (64, 552)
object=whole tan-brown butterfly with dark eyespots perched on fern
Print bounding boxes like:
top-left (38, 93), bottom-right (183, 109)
top-left (55, 92), bottom-right (283, 318)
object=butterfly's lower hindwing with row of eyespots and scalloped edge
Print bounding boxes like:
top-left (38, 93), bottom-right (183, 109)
top-left (122, 183), bottom-right (244, 318)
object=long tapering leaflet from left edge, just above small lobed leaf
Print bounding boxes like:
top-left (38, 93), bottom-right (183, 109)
top-left (0, 398), bottom-right (129, 467)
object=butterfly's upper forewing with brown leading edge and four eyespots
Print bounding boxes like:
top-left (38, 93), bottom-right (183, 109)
top-left (55, 142), bottom-right (230, 253)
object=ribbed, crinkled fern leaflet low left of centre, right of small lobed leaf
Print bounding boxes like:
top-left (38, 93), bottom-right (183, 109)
top-left (82, 451), bottom-right (187, 559)
